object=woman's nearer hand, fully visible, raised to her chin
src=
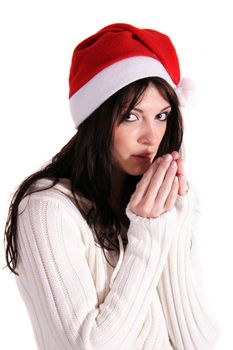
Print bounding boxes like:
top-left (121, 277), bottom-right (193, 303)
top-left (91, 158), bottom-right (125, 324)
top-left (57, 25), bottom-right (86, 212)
top-left (129, 154), bottom-right (179, 218)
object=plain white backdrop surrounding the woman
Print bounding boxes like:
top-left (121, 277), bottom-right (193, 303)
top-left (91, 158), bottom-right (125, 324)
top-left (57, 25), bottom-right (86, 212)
top-left (0, 0), bottom-right (233, 350)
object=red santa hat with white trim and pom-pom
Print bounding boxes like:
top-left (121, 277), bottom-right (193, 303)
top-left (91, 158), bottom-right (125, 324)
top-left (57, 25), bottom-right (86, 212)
top-left (69, 23), bottom-right (194, 127)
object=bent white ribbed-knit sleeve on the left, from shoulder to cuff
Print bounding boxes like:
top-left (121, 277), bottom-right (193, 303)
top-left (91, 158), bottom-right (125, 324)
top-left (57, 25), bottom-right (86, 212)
top-left (17, 192), bottom-right (177, 350)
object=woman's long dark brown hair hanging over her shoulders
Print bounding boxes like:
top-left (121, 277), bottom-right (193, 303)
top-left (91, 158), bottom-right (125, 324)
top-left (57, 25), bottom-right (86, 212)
top-left (4, 77), bottom-right (183, 274)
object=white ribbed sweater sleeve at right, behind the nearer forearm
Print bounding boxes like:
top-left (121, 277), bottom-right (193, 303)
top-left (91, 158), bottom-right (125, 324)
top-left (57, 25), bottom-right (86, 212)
top-left (158, 186), bottom-right (219, 350)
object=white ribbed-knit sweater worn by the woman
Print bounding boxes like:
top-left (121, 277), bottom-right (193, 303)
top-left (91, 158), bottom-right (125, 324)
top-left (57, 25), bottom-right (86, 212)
top-left (16, 180), bottom-right (217, 350)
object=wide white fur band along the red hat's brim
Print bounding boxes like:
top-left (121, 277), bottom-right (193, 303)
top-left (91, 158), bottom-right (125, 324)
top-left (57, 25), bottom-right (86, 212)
top-left (70, 56), bottom-right (176, 127)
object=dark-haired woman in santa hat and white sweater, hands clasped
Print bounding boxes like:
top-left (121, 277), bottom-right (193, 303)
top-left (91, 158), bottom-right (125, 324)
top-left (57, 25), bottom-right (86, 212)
top-left (5, 23), bottom-right (217, 350)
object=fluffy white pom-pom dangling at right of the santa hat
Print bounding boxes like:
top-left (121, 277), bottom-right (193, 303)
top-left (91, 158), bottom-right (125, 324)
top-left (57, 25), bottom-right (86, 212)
top-left (175, 78), bottom-right (197, 107)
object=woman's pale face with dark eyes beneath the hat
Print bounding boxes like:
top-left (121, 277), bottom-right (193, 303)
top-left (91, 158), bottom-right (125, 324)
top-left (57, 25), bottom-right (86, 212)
top-left (112, 84), bottom-right (171, 176)
